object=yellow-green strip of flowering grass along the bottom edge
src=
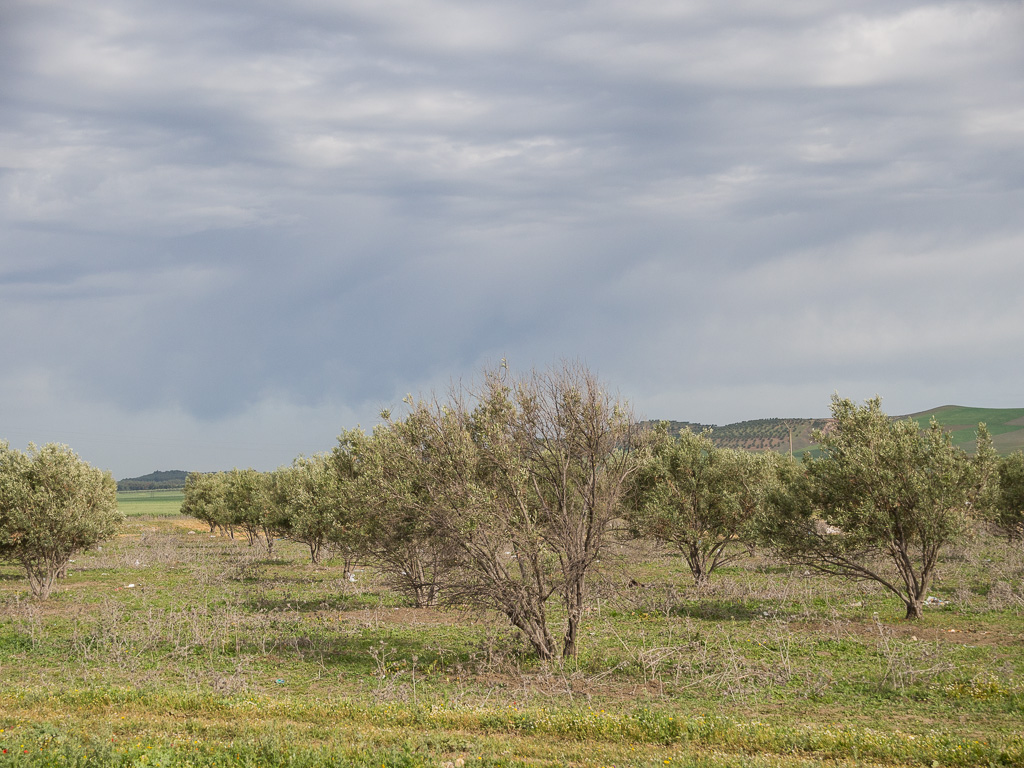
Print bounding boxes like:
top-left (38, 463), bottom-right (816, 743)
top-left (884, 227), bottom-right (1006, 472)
top-left (7, 692), bottom-right (1024, 766)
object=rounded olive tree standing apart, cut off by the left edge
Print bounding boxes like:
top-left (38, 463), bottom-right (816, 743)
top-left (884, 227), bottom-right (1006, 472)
top-left (0, 442), bottom-right (123, 599)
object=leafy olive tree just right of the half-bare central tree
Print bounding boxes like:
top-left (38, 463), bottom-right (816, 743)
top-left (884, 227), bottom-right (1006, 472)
top-left (629, 425), bottom-right (780, 586)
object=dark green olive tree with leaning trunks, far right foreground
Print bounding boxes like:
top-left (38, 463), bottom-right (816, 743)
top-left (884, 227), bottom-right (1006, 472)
top-left (762, 395), bottom-right (992, 618)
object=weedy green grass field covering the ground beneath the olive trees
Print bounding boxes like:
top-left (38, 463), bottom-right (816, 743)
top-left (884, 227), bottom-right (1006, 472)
top-left (0, 518), bottom-right (1024, 768)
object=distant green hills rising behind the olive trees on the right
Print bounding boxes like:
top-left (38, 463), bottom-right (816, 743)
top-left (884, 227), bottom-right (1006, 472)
top-left (644, 406), bottom-right (1024, 456)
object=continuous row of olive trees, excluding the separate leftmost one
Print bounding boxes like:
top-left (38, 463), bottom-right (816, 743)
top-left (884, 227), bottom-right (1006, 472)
top-left (182, 365), bottom-right (1024, 658)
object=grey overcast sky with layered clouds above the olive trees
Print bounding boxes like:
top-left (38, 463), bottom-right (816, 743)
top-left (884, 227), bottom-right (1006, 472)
top-left (0, 0), bottom-right (1024, 478)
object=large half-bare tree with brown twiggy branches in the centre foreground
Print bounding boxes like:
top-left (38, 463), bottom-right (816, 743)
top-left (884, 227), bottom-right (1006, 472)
top-left (358, 366), bottom-right (641, 658)
